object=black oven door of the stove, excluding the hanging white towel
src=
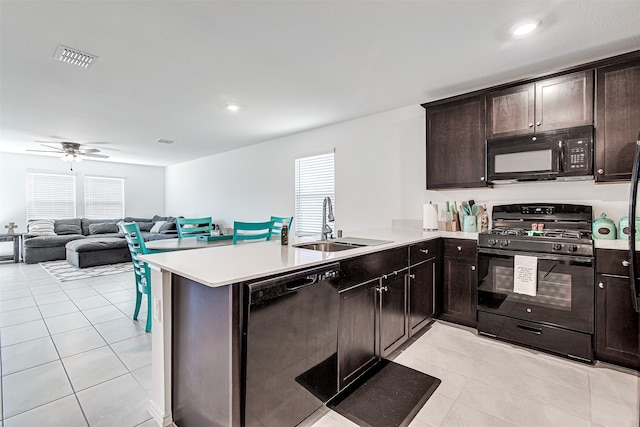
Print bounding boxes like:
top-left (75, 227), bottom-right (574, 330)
top-left (478, 248), bottom-right (595, 333)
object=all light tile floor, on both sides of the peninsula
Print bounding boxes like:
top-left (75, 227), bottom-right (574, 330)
top-left (0, 263), bottom-right (640, 427)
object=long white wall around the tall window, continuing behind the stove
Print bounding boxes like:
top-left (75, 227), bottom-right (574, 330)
top-left (166, 106), bottom-right (629, 237)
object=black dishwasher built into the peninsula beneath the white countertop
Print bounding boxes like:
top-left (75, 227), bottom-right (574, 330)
top-left (243, 263), bottom-right (340, 427)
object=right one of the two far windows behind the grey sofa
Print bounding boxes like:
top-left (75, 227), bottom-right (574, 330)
top-left (84, 176), bottom-right (124, 218)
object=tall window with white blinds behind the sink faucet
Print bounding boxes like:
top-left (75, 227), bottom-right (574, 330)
top-left (294, 153), bottom-right (335, 236)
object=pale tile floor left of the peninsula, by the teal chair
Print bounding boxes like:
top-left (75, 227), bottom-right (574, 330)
top-left (0, 263), bottom-right (157, 427)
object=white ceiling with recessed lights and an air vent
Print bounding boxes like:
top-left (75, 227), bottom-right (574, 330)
top-left (0, 0), bottom-right (640, 165)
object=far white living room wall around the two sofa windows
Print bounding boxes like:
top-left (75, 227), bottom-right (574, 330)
top-left (0, 153), bottom-right (165, 232)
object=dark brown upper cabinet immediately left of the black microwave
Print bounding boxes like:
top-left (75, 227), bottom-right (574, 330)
top-left (427, 95), bottom-right (487, 190)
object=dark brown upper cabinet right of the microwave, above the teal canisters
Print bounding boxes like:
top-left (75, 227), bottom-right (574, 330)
top-left (595, 59), bottom-right (640, 182)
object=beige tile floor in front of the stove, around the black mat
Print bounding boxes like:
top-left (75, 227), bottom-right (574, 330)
top-left (313, 321), bottom-right (640, 427)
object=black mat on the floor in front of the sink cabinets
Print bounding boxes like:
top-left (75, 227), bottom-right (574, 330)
top-left (327, 360), bottom-right (441, 427)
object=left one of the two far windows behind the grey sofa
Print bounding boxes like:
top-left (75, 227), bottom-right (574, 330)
top-left (26, 172), bottom-right (76, 220)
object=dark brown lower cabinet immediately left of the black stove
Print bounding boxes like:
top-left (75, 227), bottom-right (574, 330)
top-left (440, 239), bottom-right (478, 328)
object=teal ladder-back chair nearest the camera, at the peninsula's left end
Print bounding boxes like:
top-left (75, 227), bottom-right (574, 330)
top-left (118, 222), bottom-right (162, 332)
